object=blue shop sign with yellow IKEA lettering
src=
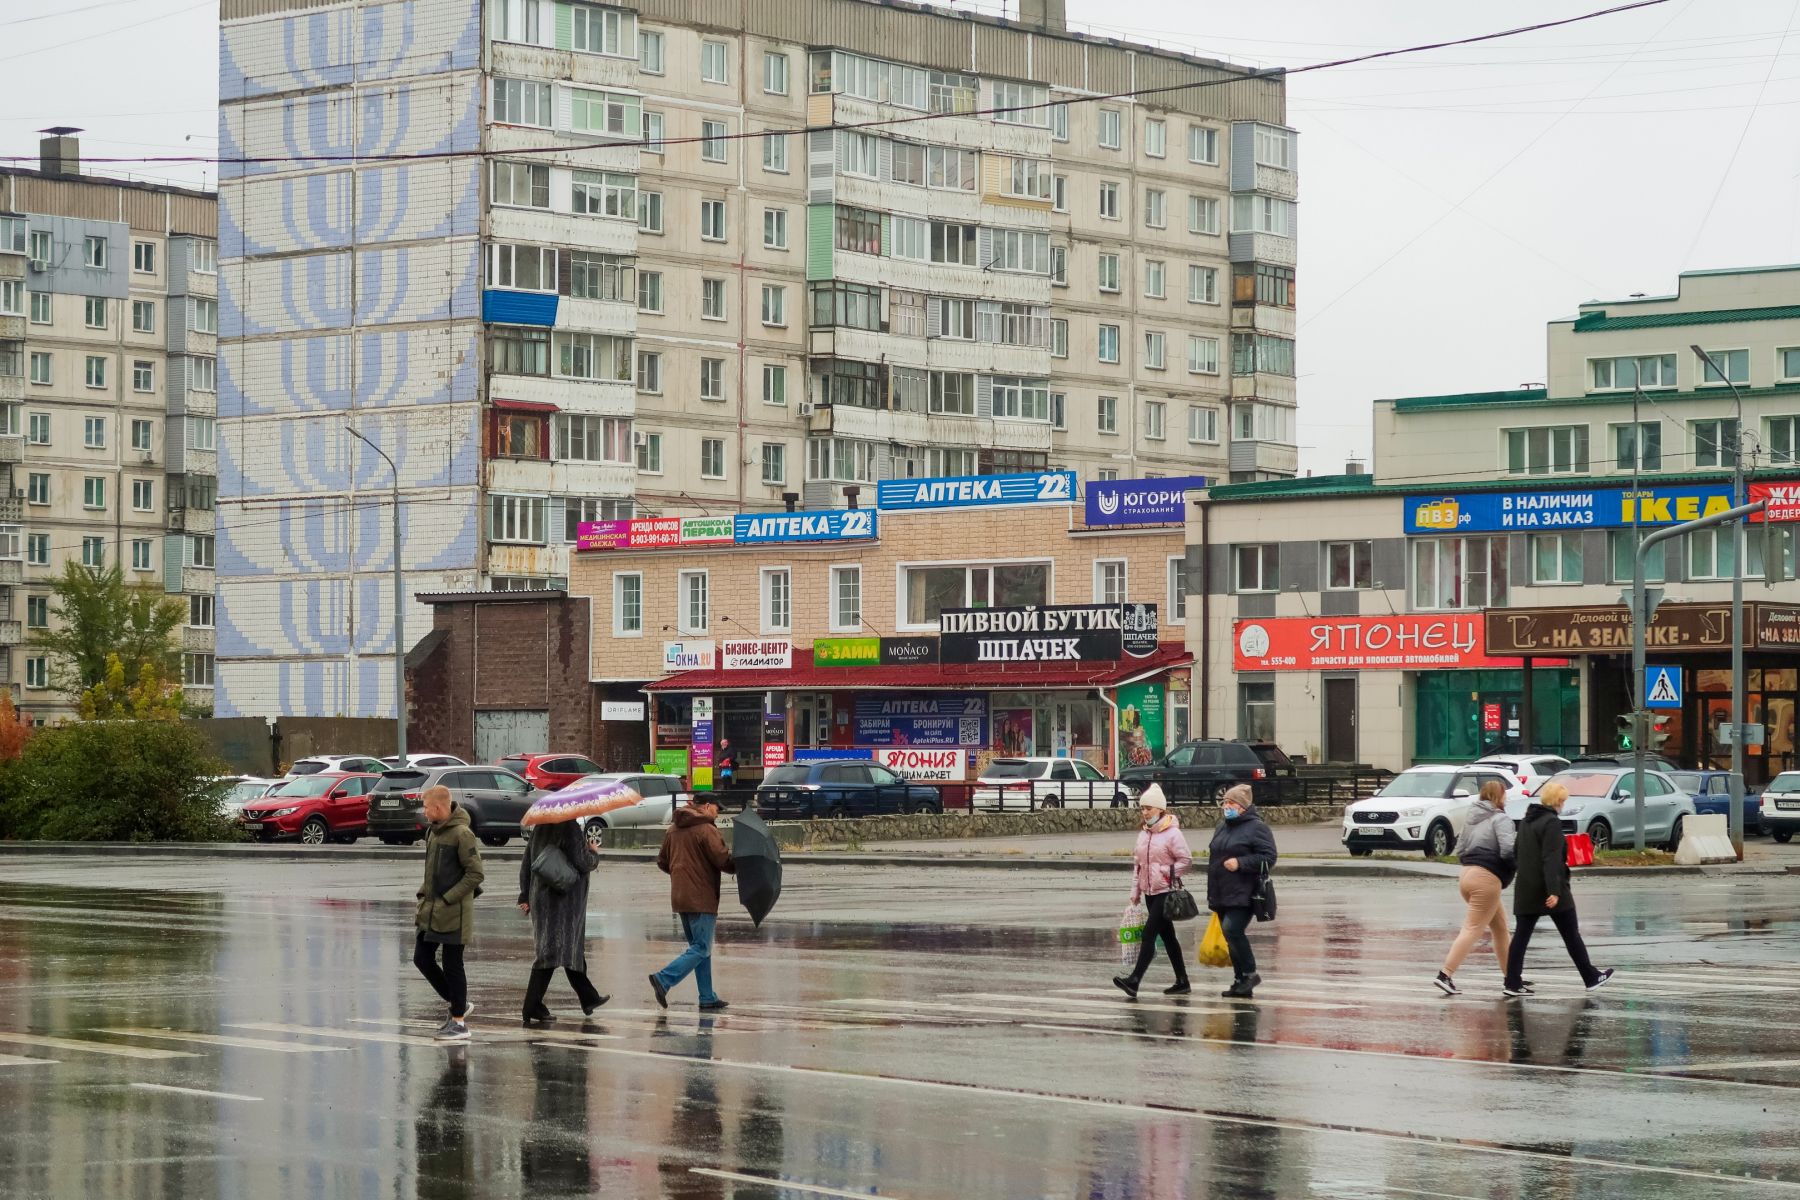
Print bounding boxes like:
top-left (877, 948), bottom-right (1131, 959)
top-left (1406, 484), bottom-right (1732, 534)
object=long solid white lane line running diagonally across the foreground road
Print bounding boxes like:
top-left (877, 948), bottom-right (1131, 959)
top-left (554, 1031), bottom-right (1800, 1195)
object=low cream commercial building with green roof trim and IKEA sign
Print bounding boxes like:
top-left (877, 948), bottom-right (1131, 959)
top-left (1188, 266), bottom-right (1800, 784)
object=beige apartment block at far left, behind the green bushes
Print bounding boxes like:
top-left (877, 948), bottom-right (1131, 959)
top-left (0, 138), bottom-right (218, 720)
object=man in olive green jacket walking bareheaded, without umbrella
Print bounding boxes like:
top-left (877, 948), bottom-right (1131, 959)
top-left (412, 784), bottom-right (482, 1042)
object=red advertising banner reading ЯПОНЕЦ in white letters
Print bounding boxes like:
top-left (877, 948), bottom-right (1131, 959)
top-left (1231, 612), bottom-right (1566, 671)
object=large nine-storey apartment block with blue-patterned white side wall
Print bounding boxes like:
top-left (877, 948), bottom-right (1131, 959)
top-left (220, 0), bottom-right (1296, 714)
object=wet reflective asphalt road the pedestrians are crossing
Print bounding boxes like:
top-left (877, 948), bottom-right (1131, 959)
top-left (0, 858), bottom-right (1800, 1200)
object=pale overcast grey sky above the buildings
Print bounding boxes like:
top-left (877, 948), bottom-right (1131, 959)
top-left (0, 0), bottom-right (1800, 473)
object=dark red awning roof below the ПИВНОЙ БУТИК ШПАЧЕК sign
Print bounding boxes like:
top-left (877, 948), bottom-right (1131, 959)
top-left (644, 642), bottom-right (1193, 693)
